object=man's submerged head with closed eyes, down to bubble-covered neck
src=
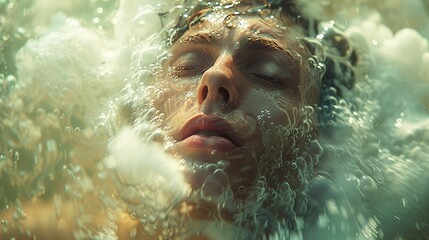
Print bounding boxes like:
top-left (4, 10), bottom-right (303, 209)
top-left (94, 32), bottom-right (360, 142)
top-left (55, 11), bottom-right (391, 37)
top-left (114, 1), bottom-right (358, 236)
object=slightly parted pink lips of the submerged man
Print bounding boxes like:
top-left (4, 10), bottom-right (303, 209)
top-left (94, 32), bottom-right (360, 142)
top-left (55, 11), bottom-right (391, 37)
top-left (176, 115), bottom-right (240, 154)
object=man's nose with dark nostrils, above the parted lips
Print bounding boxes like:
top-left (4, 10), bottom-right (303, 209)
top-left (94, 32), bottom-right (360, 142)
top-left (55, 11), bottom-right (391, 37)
top-left (197, 54), bottom-right (238, 106)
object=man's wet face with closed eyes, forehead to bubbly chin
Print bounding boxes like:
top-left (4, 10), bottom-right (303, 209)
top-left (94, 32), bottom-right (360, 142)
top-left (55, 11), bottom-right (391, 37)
top-left (150, 13), bottom-right (315, 202)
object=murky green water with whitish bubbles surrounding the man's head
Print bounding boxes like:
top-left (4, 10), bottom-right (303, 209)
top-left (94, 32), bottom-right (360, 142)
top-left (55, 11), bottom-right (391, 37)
top-left (0, 0), bottom-right (429, 239)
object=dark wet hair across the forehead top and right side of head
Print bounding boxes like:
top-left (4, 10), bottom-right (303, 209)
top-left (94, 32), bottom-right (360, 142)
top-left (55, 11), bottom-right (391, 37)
top-left (167, 0), bottom-right (358, 125)
